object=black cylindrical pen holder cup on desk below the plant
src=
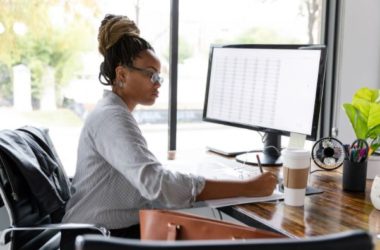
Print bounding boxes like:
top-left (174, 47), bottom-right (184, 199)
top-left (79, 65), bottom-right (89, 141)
top-left (343, 160), bottom-right (367, 192)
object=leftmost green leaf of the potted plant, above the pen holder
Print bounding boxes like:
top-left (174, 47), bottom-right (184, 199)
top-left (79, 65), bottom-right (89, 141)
top-left (343, 103), bottom-right (368, 139)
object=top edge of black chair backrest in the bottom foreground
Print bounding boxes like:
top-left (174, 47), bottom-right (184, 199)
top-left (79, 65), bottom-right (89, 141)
top-left (76, 231), bottom-right (373, 250)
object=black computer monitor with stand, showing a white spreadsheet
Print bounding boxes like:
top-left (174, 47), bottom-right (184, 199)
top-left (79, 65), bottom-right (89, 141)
top-left (203, 44), bottom-right (326, 166)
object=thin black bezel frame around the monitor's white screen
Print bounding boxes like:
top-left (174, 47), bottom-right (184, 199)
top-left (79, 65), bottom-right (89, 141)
top-left (202, 44), bottom-right (327, 141)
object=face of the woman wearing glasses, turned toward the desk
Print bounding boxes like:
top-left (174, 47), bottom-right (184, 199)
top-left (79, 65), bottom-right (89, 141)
top-left (116, 50), bottom-right (161, 111)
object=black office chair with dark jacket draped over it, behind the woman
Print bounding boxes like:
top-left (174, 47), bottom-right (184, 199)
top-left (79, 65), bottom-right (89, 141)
top-left (0, 127), bottom-right (109, 250)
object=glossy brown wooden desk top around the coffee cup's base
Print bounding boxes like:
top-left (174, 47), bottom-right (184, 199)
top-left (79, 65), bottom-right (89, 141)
top-left (221, 172), bottom-right (380, 238)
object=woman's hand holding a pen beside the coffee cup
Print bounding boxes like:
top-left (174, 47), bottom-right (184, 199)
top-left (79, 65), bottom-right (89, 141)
top-left (243, 172), bottom-right (277, 197)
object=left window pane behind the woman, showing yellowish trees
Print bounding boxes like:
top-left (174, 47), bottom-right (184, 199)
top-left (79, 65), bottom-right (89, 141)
top-left (0, 0), bottom-right (170, 176)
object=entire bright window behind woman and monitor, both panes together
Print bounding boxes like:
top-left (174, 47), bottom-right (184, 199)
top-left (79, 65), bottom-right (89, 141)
top-left (0, 0), bottom-right (324, 176)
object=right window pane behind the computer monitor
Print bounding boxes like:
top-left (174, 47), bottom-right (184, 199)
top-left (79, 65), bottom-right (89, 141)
top-left (177, 0), bottom-right (323, 150)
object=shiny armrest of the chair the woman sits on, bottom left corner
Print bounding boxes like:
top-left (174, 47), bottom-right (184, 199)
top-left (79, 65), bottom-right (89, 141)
top-left (0, 223), bottom-right (111, 245)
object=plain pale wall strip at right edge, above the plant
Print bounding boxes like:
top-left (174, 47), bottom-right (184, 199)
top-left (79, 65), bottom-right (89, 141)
top-left (333, 0), bottom-right (380, 143)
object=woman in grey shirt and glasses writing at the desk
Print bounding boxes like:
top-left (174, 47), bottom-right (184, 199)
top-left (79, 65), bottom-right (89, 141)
top-left (63, 15), bottom-right (276, 250)
